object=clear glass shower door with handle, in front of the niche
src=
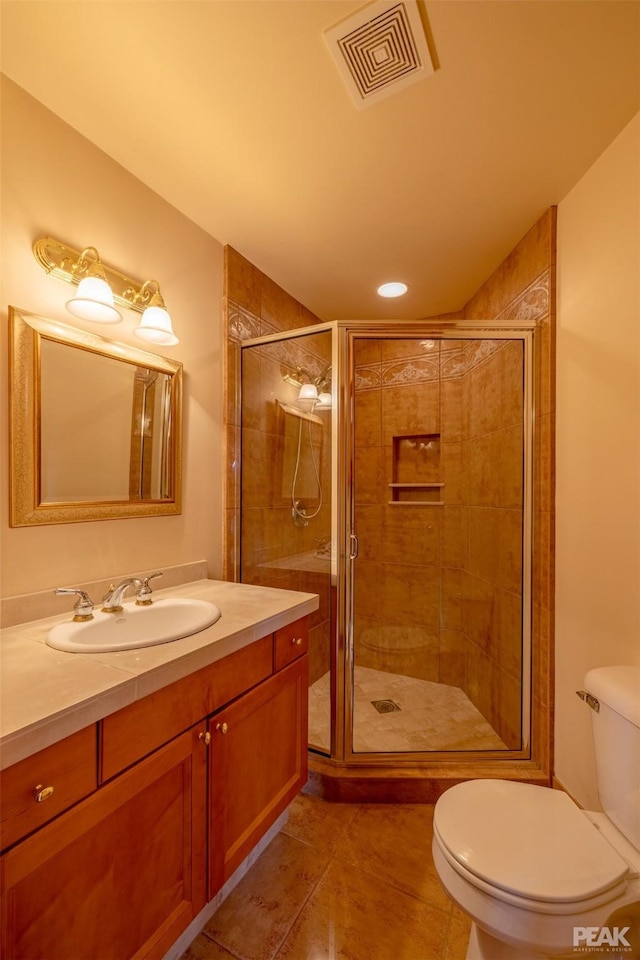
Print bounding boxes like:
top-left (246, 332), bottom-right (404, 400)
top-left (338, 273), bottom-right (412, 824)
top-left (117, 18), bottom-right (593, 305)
top-left (349, 332), bottom-right (530, 755)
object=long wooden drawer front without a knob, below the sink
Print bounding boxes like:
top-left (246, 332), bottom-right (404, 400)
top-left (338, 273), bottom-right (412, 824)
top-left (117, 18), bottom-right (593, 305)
top-left (100, 634), bottom-right (273, 783)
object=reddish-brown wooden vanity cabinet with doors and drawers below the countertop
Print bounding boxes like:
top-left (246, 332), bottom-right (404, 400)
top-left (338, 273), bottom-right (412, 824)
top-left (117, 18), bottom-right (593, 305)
top-left (0, 618), bottom-right (308, 960)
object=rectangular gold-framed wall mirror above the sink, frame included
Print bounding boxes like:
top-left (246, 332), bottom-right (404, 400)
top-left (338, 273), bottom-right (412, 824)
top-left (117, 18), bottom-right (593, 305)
top-left (9, 307), bottom-right (182, 527)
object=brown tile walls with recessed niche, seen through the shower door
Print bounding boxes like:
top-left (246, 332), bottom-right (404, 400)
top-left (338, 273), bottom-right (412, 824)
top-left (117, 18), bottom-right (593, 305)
top-left (354, 340), bottom-right (522, 749)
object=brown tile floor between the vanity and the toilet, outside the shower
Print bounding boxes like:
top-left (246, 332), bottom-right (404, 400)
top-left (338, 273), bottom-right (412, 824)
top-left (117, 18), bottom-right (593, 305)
top-left (182, 794), bottom-right (470, 960)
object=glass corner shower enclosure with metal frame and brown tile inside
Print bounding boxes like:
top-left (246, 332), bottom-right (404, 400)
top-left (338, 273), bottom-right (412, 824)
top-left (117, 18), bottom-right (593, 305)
top-left (240, 321), bottom-right (547, 799)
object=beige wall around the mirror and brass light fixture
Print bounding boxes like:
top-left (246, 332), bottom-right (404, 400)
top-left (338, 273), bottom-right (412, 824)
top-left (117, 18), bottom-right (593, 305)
top-left (0, 79), bottom-right (223, 597)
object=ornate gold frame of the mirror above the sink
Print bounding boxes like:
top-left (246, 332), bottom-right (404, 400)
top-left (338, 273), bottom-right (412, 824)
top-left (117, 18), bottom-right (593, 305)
top-left (9, 307), bottom-right (182, 527)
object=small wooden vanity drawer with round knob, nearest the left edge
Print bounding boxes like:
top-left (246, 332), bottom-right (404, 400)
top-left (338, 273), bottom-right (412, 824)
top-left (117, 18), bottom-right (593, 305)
top-left (0, 724), bottom-right (98, 850)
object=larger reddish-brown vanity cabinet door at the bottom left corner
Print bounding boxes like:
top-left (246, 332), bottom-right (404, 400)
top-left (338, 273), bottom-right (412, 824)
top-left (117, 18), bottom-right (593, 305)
top-left (0, 723), bottom-right (207, 960)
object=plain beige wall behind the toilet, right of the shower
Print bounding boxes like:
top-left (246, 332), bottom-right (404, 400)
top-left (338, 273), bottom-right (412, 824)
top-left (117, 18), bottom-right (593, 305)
top-left (555, 115), bottom-right (640, 809)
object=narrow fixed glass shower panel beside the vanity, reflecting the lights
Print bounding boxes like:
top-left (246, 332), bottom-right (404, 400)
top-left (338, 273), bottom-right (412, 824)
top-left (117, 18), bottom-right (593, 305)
top-left (240, 328), bottom-right (335, 753)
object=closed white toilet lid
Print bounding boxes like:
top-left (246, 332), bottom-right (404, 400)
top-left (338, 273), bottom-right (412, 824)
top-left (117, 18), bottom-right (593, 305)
top-left (434, 780), bottom-right (628, 901)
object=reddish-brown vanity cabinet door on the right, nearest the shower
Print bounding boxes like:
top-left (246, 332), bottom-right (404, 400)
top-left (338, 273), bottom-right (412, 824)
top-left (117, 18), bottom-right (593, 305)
top-left (209, 656), bottom-right (307, 897)
